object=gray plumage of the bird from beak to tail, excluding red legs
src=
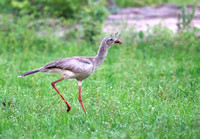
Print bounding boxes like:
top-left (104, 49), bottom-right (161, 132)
top-left (18, 34), bottom-right (121, 81)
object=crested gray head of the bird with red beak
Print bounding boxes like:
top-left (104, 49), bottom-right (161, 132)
top-left (103, 32), bottom-right (122, 47)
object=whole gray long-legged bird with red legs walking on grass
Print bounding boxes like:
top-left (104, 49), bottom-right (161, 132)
top-left (18, 33), bottom-right (122, 114)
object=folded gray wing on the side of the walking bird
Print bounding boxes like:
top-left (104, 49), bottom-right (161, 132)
top-left (44, 57), bottom-right (93, 73)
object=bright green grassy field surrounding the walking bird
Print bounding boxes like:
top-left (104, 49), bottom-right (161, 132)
top-left (0, 16), bottom-right (200, 138)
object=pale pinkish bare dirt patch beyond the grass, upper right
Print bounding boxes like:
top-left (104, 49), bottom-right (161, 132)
top-left (103, 4), bottom-right (200, 32)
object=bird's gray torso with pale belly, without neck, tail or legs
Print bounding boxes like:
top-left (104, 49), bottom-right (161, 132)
top-left (41, 56), bottom-right (95, 80)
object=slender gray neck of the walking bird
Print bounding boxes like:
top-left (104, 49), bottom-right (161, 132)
top-left (95, 43), bottom-right (108, 67)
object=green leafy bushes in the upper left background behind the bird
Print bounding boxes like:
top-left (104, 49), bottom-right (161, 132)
top-left (2, 0), bottom-right (108, 42)
